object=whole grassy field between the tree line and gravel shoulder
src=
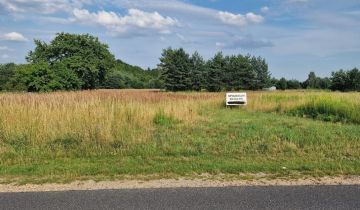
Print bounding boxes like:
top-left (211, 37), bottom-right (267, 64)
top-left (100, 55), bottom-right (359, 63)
top-left (0, 90), bottom-right (360, 183)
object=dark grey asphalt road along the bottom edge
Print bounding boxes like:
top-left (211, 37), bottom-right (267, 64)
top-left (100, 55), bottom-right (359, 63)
top-left (0, 186), bottom-right (360, 210)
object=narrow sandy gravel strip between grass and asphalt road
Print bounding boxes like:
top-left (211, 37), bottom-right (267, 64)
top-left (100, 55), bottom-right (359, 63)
top-left (0, 176), bottom-right (360, 192)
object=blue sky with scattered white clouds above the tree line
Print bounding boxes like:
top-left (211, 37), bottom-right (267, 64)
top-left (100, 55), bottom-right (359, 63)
top-left (0, 0), bottom-right (360, 80)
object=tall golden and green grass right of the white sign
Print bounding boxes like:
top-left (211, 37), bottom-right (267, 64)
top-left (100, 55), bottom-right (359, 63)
top-left (247, 91), bottom-right (360, 123)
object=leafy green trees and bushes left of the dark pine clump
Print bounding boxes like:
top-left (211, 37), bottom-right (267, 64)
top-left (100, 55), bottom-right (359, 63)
top-left (0, 33), bottom-right (163, 92)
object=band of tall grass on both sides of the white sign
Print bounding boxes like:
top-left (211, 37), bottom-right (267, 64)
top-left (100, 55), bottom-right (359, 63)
top-left (0, 90), bottom-right (360, 149)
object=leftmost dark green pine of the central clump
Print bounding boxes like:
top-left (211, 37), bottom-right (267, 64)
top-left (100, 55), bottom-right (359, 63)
top-left (159, 48), bottom-right (191, 91)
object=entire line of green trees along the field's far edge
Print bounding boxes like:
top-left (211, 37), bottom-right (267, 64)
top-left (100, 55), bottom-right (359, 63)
top-left (0, 33), bottom-right (360, 92)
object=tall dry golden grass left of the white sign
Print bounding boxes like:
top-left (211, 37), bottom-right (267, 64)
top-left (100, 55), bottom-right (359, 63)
top-left (0, 90), bottom-right (221, 147)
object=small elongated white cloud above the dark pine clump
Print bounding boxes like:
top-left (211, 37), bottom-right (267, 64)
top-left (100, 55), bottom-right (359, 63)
top-left (218, 11), bottom-right (264, 27)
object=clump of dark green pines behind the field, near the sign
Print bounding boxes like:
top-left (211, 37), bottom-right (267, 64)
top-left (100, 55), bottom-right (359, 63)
top-left (159, 48), bottom-right (270, 92)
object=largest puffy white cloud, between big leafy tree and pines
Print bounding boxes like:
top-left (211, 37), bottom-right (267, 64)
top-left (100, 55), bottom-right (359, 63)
top-left (73, 9), bottom-right (179, 34)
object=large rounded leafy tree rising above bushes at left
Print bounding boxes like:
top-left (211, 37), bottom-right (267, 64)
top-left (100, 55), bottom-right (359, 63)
top-left (26, 33), bottom-right (115, 89)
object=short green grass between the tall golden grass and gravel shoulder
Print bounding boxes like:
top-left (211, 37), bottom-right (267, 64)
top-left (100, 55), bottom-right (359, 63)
top-left (0, 105), bottom-right (360, 183)
